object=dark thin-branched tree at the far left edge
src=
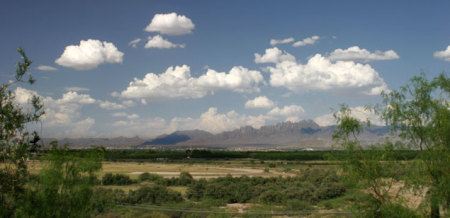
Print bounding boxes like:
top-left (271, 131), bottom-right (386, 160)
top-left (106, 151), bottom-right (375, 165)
top-left (0, 48), bottom-right (44, 217)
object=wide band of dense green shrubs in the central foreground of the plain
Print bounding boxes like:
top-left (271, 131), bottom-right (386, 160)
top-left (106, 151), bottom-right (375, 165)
top-left (186, 170), bottom-right (346, 205)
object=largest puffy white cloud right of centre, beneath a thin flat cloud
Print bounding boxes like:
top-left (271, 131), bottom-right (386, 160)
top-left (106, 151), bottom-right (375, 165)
top-left (268, 54), bottom-right (388, 95)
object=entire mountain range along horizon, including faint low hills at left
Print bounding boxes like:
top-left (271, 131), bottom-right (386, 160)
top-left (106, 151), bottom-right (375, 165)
top-left (46, 120), bottom-right (388, 149)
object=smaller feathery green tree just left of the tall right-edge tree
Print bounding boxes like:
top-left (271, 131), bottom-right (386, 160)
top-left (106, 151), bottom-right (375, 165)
top-left (333, 104), bottom-right (401, 217)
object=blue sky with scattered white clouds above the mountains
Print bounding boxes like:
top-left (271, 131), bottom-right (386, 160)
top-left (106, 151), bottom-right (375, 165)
top-left (0, 0), bottom-right (450, 138)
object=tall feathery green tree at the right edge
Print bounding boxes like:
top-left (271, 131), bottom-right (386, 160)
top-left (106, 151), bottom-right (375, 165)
top-left (379, 73), bottom-right (450, 217)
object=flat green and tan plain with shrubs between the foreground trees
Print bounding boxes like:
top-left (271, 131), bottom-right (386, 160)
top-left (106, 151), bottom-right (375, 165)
top-left (15, 150), bottom-right (432, 217)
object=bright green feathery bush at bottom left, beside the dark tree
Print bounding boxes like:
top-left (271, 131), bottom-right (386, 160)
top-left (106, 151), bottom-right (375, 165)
top-left (16, 142), bottom-right (103, 217)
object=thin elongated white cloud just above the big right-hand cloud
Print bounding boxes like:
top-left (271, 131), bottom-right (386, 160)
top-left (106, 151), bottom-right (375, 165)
top-left (328, 46), bottom-right (400, 62)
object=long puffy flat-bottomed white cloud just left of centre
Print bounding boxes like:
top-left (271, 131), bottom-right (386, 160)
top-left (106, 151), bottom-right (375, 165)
top-left (116, 65), bottom-right (264, 101)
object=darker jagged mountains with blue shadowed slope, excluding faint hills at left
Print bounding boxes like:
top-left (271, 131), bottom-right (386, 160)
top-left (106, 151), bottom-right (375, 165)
top-left (142, 120), bottom-right (388, 149)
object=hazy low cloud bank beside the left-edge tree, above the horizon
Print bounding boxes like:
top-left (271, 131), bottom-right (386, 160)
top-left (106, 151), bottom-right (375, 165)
top-left (14, 87), bottom-right (141, 138)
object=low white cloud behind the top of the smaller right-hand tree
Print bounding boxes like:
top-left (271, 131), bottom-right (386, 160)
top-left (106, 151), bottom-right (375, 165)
top-left (314, 106), bottom-right (384, 126)
